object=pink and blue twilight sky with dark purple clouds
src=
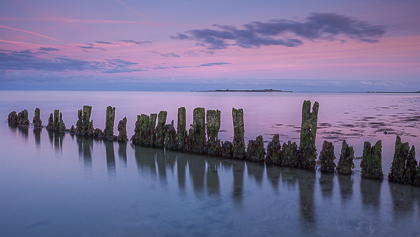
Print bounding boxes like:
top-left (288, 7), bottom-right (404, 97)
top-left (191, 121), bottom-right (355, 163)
top-left (0, 0), bottom-right (420, 92)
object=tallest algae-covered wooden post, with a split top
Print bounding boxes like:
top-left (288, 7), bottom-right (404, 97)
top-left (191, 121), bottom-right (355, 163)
top-left (299, 100), bottom-right (319, 169)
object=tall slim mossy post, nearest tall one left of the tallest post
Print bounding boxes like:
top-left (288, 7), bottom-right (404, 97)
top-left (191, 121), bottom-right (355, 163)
top-left (232, 108), bottom-right (246, 159)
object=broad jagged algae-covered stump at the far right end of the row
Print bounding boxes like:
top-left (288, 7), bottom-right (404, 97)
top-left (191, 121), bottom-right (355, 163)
top-left (388, 136), bottom-right (417, 184)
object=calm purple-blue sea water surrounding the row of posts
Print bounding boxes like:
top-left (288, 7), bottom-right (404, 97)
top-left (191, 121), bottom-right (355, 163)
top-left (0, 91), bottom-right (420, 236)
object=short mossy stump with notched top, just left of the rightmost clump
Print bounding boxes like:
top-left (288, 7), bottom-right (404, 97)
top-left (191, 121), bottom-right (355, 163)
top-left (360, 140), bottom-right (384, 179)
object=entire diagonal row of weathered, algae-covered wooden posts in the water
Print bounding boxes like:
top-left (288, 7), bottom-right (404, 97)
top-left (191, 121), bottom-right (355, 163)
top-left (8, 101), bottom-right (420, 186)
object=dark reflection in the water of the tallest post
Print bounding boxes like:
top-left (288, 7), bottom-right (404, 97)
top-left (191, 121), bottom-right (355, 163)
top-left (297, 170), bottom-right (316, 234)
